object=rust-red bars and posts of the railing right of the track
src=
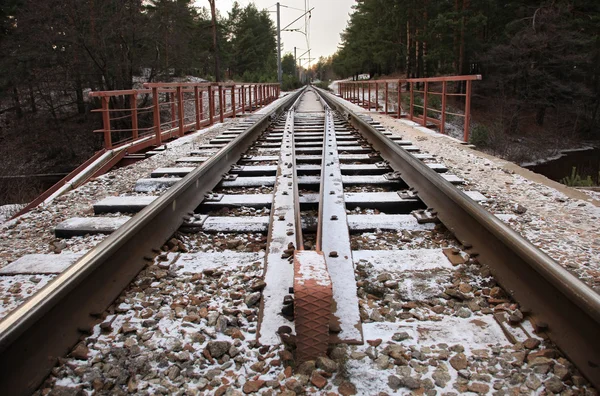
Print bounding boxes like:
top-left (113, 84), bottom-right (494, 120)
top-left (339, 75), bottom-right (481, 142)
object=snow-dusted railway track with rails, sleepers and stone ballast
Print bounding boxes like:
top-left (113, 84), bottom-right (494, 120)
top-left (0, 88), bottom-right (600, 394)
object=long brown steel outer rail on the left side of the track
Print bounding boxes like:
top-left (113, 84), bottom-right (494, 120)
top-left (0, 90), bottom-right (302, 395)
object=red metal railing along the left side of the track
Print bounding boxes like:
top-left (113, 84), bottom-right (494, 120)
top-left (90, 83), bottom-right (280, 152)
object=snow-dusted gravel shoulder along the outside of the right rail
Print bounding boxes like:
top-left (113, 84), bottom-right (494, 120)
top-left (368, 110), bottom-right (600, 291)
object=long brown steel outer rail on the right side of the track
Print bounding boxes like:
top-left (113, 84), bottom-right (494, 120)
top-left (320, 86), bottom-right (600, 388)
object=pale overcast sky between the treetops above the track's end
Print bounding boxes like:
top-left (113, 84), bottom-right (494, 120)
top-left (195, 0), bottom-right (354, 67)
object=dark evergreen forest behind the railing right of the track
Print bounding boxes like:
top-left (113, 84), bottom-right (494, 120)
top-left (329, 0), bottom-right (600, 161)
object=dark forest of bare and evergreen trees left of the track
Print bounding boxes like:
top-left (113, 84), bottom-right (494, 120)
top-left (0, 0), bottom-right (277, 204)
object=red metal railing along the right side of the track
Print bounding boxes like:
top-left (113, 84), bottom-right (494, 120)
top-left (338, 75), bottom-right (481, 142)
